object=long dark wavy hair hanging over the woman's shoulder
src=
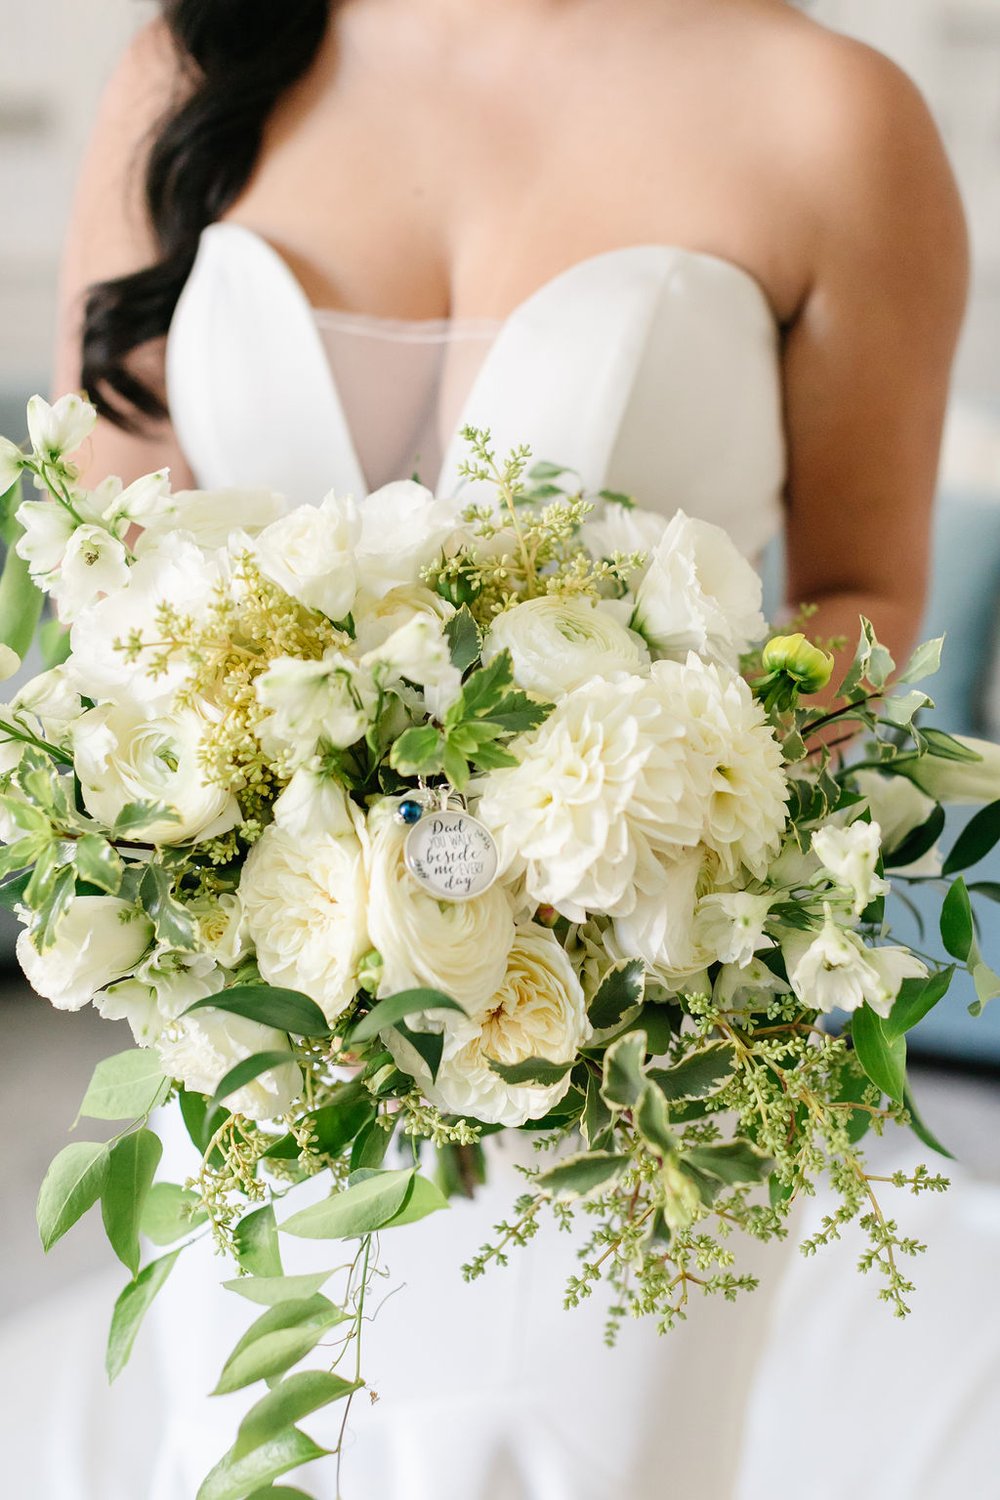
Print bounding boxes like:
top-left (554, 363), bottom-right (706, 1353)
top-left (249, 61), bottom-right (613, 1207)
top-left (82, 0), bottom-right (336, 432)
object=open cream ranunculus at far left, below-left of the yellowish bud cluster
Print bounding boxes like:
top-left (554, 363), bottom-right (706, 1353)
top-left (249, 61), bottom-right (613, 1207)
top-left (72, 698), bottom-right (240, 845)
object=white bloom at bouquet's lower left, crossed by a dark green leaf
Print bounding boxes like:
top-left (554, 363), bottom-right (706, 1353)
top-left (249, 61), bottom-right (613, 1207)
top-left (157, 1010), bottom-right (301, 1121)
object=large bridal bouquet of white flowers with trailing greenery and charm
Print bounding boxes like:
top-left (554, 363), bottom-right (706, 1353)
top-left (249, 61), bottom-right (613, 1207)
top-left (0, 396), bottom-right (1000, 1500)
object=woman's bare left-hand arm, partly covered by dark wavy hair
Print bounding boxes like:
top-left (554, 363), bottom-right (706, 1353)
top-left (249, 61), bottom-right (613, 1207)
top-left (54, 23), bottom-right (192, 489)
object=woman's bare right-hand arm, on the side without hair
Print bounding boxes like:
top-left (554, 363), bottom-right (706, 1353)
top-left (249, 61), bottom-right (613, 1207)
top-left (784, 39), bottom-right (969, 672)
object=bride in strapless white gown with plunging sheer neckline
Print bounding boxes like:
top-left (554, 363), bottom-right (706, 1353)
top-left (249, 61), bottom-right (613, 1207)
top-left (39, 0), bottom-right (967, 1500)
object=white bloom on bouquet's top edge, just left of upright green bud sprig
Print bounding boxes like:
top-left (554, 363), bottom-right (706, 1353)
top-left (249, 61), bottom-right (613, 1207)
top-left (358, 480), bottom-right (459, 597)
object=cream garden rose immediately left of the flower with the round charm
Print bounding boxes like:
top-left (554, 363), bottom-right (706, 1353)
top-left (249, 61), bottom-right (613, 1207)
top-left (240, 794), bottom-right (370, 1022)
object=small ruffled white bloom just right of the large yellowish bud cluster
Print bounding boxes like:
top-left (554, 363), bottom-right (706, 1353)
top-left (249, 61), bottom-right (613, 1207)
top-left (255, 647), bottom-right (378, 767)
